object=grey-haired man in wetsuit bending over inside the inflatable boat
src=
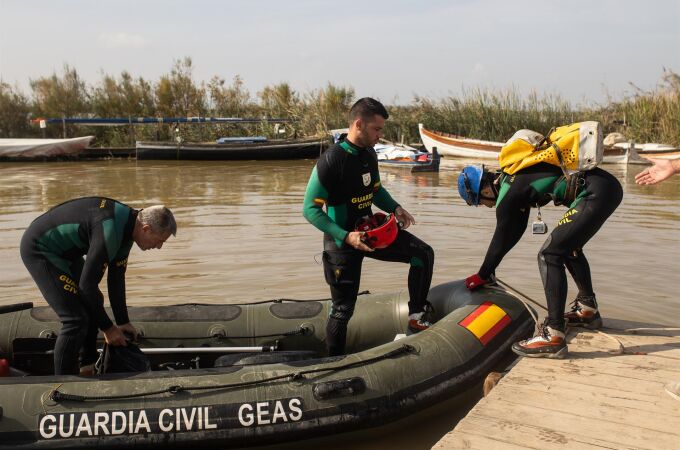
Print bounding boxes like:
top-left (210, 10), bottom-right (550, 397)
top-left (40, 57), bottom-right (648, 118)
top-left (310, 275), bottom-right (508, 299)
top-left (21, 197), bottom-right (177, 375)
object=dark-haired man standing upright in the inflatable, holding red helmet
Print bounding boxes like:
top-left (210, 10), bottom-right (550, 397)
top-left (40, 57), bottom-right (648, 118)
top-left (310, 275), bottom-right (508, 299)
top-left (303, 98), bottom-right (434, 356)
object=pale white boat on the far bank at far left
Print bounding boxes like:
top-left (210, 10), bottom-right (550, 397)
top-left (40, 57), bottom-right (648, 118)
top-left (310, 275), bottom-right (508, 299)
top-left (0, 136), bottom-right (94, 161)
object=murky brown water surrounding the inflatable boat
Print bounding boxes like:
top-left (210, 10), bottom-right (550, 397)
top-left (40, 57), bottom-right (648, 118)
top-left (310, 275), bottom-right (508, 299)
top-left (0, 161), bottom-right (680, 448)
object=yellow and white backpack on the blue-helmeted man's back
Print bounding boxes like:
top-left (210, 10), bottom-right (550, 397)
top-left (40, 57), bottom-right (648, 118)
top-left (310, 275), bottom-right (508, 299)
top-left (498, 121), bottom-right (603, 176)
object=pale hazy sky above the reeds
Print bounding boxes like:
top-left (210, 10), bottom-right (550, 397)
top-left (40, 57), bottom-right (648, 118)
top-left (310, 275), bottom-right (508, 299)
top-left (0, 0), bottom-right (680, 103)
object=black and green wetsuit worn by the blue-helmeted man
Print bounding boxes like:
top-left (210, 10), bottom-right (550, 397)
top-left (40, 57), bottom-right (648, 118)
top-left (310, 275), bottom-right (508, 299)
top-left (479, 163), bottom-right (623, 330)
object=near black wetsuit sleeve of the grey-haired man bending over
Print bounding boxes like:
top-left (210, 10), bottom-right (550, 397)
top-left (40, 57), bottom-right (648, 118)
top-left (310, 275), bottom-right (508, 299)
top-left (79, 224), bottom-right (113, 330)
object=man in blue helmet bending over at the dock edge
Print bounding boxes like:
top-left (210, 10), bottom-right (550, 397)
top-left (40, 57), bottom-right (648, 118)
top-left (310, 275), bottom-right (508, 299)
top-left (458, 163), bottom-right (623, 358)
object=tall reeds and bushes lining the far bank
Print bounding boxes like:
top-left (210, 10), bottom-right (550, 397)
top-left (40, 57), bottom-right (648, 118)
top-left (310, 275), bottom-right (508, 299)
top-left (0, 58), bottom-right (680, 147)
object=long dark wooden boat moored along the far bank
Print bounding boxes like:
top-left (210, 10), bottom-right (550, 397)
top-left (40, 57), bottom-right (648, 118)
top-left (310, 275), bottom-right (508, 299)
top-left (136, 138), bottom-right (327, 160)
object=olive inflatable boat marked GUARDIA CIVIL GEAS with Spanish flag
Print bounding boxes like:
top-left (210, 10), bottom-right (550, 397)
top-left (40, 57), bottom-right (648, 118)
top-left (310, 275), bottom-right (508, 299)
top-left (0, 281), bottom-right (534, 448)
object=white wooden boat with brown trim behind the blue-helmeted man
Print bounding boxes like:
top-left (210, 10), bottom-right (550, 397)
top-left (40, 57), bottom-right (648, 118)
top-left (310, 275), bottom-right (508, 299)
top-left (418, 123), bottom-right (635, 164)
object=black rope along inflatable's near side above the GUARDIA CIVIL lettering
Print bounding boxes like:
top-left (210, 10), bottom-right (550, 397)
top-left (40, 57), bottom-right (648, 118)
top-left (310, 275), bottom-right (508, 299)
top-left (49, 344), bottom-right (418, 402)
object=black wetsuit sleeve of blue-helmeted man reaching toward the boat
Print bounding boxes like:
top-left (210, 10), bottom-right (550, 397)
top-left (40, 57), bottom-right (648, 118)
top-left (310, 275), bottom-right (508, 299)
top-left (479, 198), bottom-right (531, 280)
